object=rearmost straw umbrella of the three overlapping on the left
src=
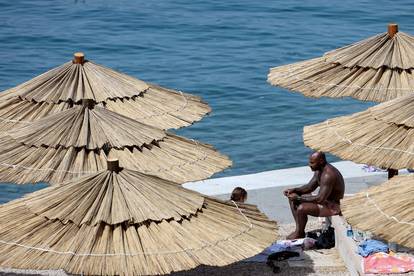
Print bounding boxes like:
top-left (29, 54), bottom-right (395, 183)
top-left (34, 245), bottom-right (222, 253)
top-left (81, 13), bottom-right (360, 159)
top-left (0, 53), bottom-right (211, 131)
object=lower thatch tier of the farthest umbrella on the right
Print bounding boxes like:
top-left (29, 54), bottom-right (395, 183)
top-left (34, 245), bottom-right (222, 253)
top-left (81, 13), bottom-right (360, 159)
top-left (268, 57), bottom-right (414, 102)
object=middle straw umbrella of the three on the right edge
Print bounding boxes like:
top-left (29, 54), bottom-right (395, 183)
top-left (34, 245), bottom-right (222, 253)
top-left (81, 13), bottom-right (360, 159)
top-left (303, 92), bottom-right (414, 169)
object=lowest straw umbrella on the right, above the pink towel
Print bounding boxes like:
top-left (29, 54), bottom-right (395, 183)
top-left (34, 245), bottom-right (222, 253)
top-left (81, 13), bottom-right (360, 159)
top-left (341, 175), bottom-right (414, 248)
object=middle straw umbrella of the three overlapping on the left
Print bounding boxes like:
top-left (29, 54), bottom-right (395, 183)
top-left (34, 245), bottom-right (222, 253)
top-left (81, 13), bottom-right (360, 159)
top-left (0, 100), bottom-right (231, 184)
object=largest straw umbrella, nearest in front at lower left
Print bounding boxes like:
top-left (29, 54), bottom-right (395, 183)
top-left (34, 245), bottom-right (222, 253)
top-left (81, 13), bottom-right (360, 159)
top-left (0, 158), bottom-right (276, 275)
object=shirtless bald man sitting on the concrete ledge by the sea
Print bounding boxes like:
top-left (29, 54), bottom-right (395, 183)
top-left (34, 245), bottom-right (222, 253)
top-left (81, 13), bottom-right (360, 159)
top-left (283, 152), bottom-right (345, 240)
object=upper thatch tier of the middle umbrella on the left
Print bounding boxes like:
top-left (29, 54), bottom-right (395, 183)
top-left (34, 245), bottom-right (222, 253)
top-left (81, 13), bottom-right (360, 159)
top-left (7, 106), bottom-right (165, 150)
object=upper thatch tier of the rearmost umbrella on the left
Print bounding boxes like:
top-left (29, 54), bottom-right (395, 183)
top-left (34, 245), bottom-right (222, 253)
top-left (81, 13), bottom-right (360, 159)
top-left (2, 61), bottom-right (148, 104)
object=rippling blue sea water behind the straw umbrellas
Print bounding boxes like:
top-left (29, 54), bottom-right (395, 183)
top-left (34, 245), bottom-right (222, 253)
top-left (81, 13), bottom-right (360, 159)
top-left (0, 0), bottom-right (414, 202)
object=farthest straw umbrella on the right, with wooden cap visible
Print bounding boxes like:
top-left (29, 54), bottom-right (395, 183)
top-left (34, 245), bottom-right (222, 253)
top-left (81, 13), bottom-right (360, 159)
top-left (268, 24), bottom-right (414, 102)
